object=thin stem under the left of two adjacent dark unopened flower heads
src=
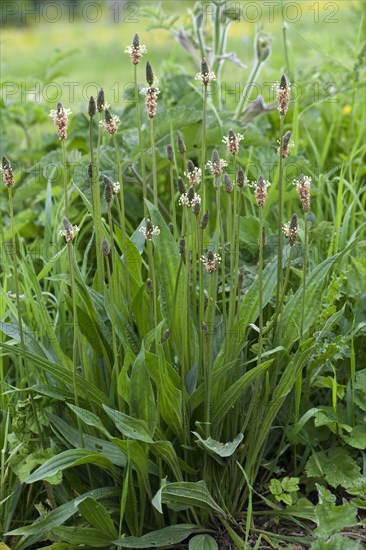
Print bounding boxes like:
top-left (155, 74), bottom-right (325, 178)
top-left (89, 118), bottom-right (104, 293)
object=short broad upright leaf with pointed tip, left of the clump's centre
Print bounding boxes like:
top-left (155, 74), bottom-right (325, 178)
top-left (129, 347), bottom-right (157, 436)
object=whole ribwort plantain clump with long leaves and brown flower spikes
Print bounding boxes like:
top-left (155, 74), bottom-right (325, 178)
top-left (0, 12), bottom-right (362, 550)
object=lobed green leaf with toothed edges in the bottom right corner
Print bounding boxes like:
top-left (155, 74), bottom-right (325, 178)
top-left (315, 483), bottom-right (357, 537)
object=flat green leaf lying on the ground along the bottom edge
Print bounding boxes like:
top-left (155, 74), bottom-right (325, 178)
top-left (114, 523), bottom-right (202, 548)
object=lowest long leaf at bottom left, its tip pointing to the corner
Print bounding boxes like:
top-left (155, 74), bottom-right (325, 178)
top-left (5, 487), bottom-right (120, 536)
